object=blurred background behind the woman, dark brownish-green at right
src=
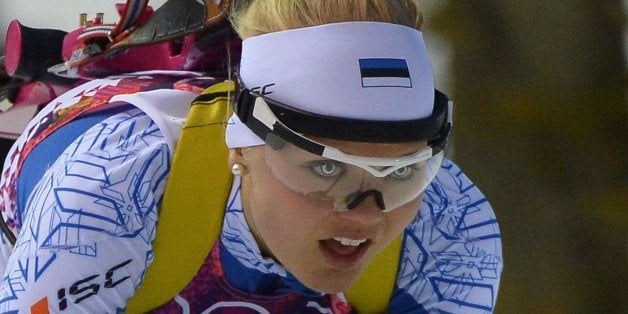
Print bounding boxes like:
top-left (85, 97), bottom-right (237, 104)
top-left (0, 0), bottom-right (628, 313)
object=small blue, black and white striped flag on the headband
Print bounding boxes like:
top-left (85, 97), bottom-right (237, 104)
top-left (359, 58), bottom-right (412, 88)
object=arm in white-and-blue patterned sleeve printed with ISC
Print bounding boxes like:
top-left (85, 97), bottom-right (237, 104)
top-left (0, 109), bottom-right (170, 313)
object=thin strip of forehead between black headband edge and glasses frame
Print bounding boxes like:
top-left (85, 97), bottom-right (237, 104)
top-left (310, 136), bottom-right (427, 157)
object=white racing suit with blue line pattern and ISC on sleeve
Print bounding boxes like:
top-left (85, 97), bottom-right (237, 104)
top-left (0, 75), bottom-right (502, 313)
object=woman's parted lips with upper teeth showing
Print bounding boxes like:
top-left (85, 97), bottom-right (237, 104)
top-left (318, 239), bottom-right (371, 269)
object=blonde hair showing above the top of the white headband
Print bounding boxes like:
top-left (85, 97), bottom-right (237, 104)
top-left (230, 0), bottom-right (423, 39)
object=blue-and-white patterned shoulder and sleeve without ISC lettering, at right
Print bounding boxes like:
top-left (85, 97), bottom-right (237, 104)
top-left (393, 160), bottom-right (502, 312)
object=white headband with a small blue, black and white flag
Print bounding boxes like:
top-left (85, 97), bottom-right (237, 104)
top-left (227, 22), bottom-right (434, 148)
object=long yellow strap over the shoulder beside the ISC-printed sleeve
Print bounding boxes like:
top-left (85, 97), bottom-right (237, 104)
top-left (127, 82), bottom-right (234, 313)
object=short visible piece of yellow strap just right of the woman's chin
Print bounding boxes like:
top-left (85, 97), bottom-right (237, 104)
top-left (345, 236), bottom-right (402, 313)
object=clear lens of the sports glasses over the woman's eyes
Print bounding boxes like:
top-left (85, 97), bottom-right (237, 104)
top-left (264, 138), bottom-right (443, 211)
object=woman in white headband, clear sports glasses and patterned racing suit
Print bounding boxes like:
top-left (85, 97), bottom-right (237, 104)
top-left (0, 0), bottom-right (502, 313)
